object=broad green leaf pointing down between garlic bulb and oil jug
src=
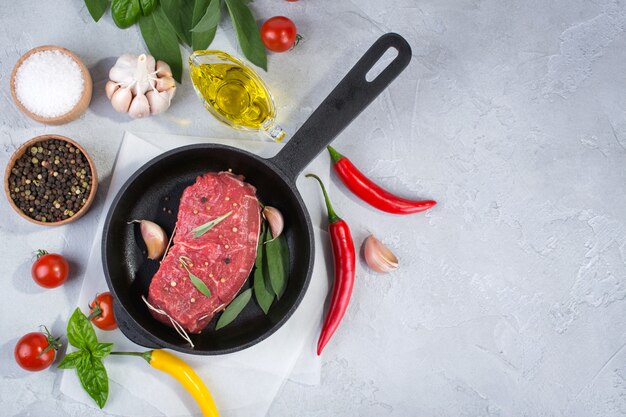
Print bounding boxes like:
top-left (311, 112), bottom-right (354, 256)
top-left (139, 7), bottom-right (183, 82)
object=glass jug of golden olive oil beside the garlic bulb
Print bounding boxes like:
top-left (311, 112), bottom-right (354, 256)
top-left (189, 51), bottom-right (285, 142)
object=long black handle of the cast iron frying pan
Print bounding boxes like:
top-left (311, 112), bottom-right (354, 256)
top-left (271, 33), bottom-right (411, 181)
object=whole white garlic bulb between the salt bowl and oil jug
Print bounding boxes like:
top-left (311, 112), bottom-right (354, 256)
top-left (104, 54), bottom-right (176, 119)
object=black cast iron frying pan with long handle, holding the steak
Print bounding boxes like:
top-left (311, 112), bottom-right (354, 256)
top-left (102, 33), bottom-right (411, 355)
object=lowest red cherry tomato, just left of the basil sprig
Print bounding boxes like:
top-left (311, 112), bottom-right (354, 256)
top-left (14, 329), bottom-right (61, 371)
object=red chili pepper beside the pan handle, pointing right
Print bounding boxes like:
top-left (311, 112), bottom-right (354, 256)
top-left (327, 146), bottom-right (437, 214)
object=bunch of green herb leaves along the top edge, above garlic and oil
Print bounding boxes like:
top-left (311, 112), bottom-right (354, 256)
top-left (85, 0), bottom-right (267, 82)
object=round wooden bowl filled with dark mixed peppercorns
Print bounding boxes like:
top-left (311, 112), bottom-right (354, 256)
top-left (4, 135), bottom-right (98, 226)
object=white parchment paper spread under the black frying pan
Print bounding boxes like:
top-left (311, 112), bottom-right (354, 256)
top-left (61, 132), bottom-right (329, 417)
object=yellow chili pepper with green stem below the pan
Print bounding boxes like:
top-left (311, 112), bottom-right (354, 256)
top-left (111, 349), bottom-right (219, 417)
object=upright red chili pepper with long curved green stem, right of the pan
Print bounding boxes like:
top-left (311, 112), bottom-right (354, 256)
top-left (306, 174), bottom-right (356, 356)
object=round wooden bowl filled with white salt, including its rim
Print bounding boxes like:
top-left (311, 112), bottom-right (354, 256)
top-left (10, 45), bottom-right (93, 125)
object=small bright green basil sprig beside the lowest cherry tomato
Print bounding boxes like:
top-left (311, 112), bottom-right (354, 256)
top-left (59, 308), bottom-right (113, 408)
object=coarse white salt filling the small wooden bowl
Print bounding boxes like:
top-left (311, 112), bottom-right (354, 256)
top-left (15, 51), bottom-right (85, 118)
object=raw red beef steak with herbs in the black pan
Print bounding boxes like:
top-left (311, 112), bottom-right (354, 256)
top-left (148, 172), bottom-right (261, 333)
